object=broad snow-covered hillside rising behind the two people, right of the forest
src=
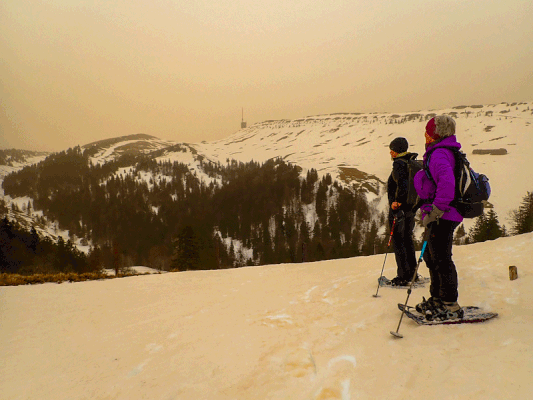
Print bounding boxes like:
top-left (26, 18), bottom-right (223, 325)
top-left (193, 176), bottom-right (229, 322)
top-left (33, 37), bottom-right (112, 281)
top-left (194, 102), bottom-right (533, 222)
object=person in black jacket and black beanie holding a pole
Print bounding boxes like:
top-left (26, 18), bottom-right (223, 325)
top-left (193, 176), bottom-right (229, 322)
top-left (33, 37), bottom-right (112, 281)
top-left (387, 137), bottom-right (418, 286)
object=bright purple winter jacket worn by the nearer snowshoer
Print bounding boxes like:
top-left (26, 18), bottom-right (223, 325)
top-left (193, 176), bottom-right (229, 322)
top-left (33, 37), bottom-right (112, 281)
top-left (414, 135), bottom-right (463, 222)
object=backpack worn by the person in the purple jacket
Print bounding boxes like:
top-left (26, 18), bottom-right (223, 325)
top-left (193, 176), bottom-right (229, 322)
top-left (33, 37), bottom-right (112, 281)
top-left (424, 146), bottom-right (491, 218)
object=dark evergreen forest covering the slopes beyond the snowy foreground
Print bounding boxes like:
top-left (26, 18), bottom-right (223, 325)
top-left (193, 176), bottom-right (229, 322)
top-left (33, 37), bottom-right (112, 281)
top-left (0, 147), bottom-right (533, 273)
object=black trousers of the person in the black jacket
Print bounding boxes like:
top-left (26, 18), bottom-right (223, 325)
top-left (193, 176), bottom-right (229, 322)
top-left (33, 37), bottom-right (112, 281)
top-left (389, 212), bottom-right (416, 281)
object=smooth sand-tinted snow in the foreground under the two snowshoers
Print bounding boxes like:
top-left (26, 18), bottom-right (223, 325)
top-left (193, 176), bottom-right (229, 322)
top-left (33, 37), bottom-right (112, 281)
top-left (0, 233), bottom-right (533, 400)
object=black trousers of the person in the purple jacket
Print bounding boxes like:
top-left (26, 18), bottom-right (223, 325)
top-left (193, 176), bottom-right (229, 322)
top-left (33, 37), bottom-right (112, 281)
top-left (424, 219), bottom-right (459, 302)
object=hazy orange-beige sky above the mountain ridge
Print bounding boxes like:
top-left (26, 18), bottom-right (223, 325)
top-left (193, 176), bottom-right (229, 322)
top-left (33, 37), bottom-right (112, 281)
top-left (0, 0), bottom-right (533, 151)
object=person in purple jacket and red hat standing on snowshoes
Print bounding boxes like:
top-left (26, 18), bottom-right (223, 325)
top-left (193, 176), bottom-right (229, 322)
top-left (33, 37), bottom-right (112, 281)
top-left (414, 115), bottom-right (463, 320)
